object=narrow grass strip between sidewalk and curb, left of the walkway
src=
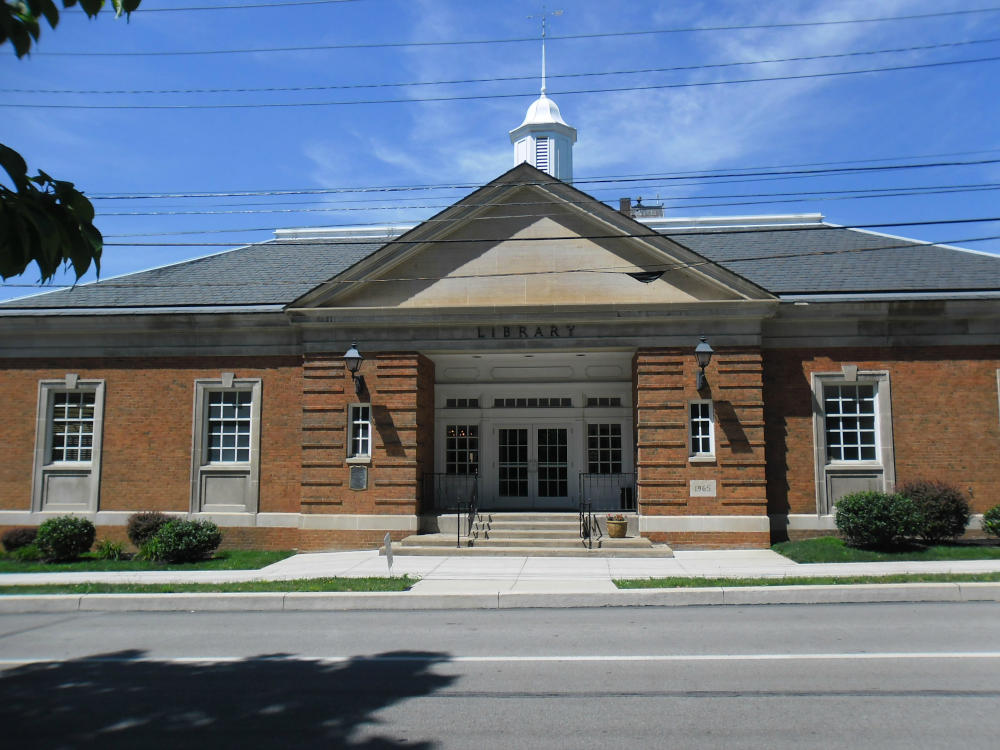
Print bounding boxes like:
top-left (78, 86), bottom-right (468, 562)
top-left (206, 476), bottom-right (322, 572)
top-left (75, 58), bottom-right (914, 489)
top-left (0, 576), bottom-right (418, 595)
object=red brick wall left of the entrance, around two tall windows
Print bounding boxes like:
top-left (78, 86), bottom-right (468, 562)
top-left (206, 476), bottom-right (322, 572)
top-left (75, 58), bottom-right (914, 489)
top-left (0, 357), bottom-right (302, 512)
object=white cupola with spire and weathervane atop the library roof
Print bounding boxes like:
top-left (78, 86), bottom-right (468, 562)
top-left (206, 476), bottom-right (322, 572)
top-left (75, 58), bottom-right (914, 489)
top-left (510, 10), bottom-right (576, 182)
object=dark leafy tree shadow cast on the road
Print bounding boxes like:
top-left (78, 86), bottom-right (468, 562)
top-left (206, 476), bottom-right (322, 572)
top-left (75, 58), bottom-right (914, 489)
top-left (0, 651), bottom-right (455, 750)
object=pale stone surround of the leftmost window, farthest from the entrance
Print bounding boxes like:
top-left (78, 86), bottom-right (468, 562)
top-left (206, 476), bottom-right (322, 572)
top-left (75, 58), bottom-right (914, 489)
top-left (31, 373), bottom-right (104, 513)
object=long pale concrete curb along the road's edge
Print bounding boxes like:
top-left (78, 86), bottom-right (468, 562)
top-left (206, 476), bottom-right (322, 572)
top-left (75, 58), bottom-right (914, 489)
top-left (0, 582), bottom-right (1000, 614)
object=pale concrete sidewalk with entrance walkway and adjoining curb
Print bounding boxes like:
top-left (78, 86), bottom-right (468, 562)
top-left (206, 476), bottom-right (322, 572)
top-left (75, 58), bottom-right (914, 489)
top-left (0, 550), bottom-right (1000, 612)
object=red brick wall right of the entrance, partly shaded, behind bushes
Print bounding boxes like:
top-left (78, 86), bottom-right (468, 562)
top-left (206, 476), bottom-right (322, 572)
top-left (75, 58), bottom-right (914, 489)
top-left (764, 347), bottom-right (1000, 514)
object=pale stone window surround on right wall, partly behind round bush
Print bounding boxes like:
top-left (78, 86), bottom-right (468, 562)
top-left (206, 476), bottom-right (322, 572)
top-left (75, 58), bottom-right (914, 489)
top-left (812, 365), bottom-right (896, 515)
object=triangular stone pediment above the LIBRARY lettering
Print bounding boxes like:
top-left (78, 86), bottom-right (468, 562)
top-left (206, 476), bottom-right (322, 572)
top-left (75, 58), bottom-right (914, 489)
top-left (294, 165), bottom-right (770, 309)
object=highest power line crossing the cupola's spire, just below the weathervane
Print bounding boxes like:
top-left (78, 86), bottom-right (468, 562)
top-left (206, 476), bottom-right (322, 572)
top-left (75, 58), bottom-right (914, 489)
top-left (34, 8), bottom-right (1000, 57)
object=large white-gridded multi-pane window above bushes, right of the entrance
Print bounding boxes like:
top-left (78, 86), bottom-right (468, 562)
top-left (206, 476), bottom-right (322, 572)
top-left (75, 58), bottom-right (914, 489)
top-left (823, 385), bottom-right (878, 461)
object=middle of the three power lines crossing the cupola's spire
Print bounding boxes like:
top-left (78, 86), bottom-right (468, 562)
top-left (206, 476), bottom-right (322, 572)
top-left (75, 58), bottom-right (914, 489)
top-left (0, 36), bottom-right (1000, 95)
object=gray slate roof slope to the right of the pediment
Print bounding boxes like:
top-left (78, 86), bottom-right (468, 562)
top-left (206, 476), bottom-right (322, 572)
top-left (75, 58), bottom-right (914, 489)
top-left (667, 224), bottom-right (1000, 296)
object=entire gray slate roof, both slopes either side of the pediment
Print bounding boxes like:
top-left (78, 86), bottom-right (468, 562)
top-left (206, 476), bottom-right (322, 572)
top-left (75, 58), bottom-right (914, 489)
top-left (0, 224), bottom-right (1000, 310)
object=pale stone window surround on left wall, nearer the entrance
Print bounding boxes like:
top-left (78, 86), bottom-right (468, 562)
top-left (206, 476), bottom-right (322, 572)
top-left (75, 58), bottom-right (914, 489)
top-left (190, 373), bottom-right (262, 513)
